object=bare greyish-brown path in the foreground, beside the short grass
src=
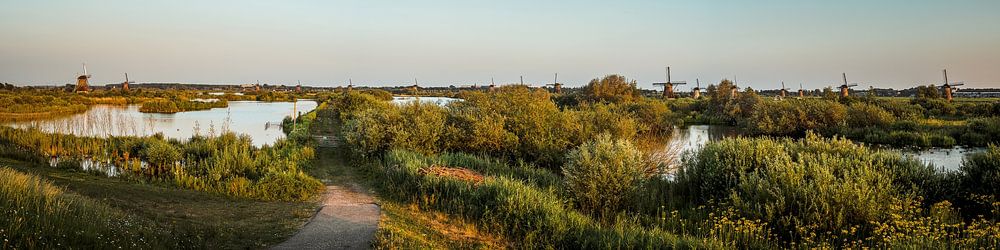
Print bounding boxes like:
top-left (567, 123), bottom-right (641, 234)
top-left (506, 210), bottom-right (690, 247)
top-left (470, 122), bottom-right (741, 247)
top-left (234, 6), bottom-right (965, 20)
top-left (274, 185), bottom-right (379, 249)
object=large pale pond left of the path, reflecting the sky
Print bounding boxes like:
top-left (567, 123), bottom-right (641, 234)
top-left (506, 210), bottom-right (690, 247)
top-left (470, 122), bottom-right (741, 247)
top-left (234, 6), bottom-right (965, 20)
top-left (0, 100), bottom-right (317, 146)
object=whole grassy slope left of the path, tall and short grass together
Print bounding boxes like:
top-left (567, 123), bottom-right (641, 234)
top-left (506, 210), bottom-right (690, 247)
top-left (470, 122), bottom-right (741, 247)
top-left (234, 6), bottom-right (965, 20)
top-left (0, 159), bottom-right (314, 249)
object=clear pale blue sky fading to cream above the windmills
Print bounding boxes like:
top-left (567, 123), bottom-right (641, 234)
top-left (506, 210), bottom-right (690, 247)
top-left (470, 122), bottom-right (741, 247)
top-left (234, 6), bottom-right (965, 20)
top-left (0, 0), bottom-right (1000, 90)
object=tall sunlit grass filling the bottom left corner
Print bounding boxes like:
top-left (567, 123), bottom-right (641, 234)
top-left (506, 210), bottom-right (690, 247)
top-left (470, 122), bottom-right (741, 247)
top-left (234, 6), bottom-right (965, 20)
top-left (0, 167), bottom-right (169, 249)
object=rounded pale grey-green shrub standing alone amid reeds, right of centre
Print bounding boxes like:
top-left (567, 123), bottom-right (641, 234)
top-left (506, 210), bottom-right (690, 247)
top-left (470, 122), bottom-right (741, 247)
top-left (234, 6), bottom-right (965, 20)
top-left (562, 135), bottom-right (653, 215)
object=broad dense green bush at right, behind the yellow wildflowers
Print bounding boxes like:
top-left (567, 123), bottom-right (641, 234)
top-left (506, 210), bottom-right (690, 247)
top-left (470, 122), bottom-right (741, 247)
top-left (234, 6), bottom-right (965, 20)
top-left (678, 134), bottom-right (932, 241)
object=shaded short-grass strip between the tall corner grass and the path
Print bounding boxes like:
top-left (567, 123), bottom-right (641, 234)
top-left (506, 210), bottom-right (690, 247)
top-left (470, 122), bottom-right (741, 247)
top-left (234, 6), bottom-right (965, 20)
top-left (0, 159), bottom-right (315, 249)
